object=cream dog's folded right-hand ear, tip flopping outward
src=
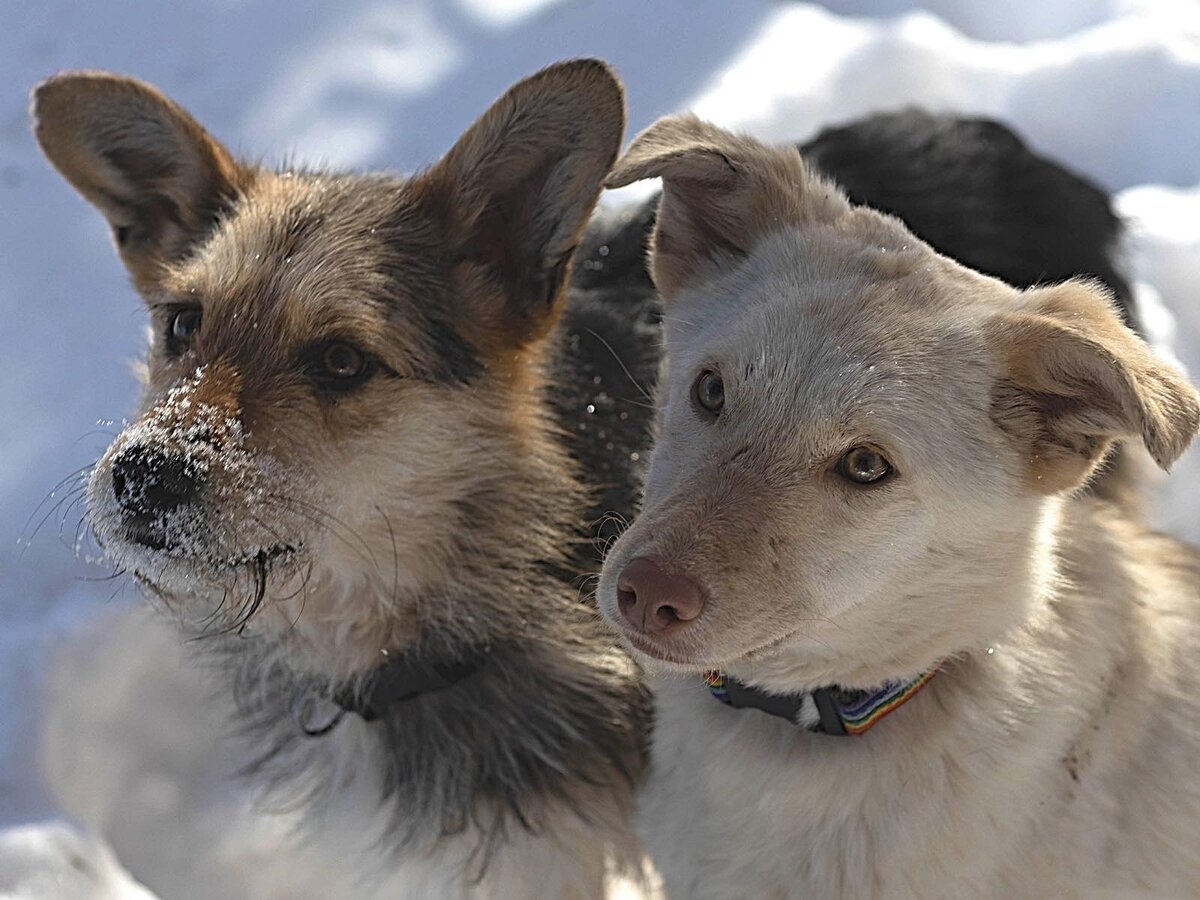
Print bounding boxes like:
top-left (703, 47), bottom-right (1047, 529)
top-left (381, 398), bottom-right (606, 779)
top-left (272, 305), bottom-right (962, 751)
top-left (986, 282), bottom-right (1200, 493)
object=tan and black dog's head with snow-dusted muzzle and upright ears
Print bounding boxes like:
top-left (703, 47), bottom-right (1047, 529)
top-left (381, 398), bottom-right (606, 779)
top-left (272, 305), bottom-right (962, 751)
top-left (32, 60), bottom-right (624, 670)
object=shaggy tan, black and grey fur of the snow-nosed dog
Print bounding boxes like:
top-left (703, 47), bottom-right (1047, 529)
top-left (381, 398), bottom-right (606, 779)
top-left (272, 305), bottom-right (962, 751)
top-left (35, 64), bottom-right (1147, 896)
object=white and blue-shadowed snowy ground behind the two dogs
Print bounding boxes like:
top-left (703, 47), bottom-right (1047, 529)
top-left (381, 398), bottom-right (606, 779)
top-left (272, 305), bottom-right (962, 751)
top-left (0, 0), bottom-right (1200, 898)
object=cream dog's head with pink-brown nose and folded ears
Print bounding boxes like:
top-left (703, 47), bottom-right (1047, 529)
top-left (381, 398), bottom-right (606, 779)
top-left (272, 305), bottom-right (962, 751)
top-left (599, 118), bottom-right (1200, 690)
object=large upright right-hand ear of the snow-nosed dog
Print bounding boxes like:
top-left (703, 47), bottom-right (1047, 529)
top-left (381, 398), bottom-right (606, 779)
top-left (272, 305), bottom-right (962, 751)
top-left (416, 59), bottom-right (625, 352)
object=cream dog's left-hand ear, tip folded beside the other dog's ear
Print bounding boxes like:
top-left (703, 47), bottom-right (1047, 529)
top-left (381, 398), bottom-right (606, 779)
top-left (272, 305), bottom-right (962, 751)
top-left (607, 115), bottom-right (848, 300)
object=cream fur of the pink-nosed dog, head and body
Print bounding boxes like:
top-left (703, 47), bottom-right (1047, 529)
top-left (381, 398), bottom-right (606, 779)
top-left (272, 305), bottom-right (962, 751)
top-left (598, 118), bottom-right (1200, 898)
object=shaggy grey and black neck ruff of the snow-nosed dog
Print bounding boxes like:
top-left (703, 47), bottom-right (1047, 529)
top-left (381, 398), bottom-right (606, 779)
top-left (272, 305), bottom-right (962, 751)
top-left (218, 585), bottom-right (648, 847)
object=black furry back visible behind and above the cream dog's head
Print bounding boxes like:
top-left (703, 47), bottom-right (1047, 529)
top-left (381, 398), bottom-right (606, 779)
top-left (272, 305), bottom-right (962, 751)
top-left (800, 109), bottom-right (1136, 326)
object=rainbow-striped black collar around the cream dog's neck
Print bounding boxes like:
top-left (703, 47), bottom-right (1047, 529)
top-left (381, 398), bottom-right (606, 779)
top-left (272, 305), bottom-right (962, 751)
top-left (704, 666), bottom-right (938, 737)
